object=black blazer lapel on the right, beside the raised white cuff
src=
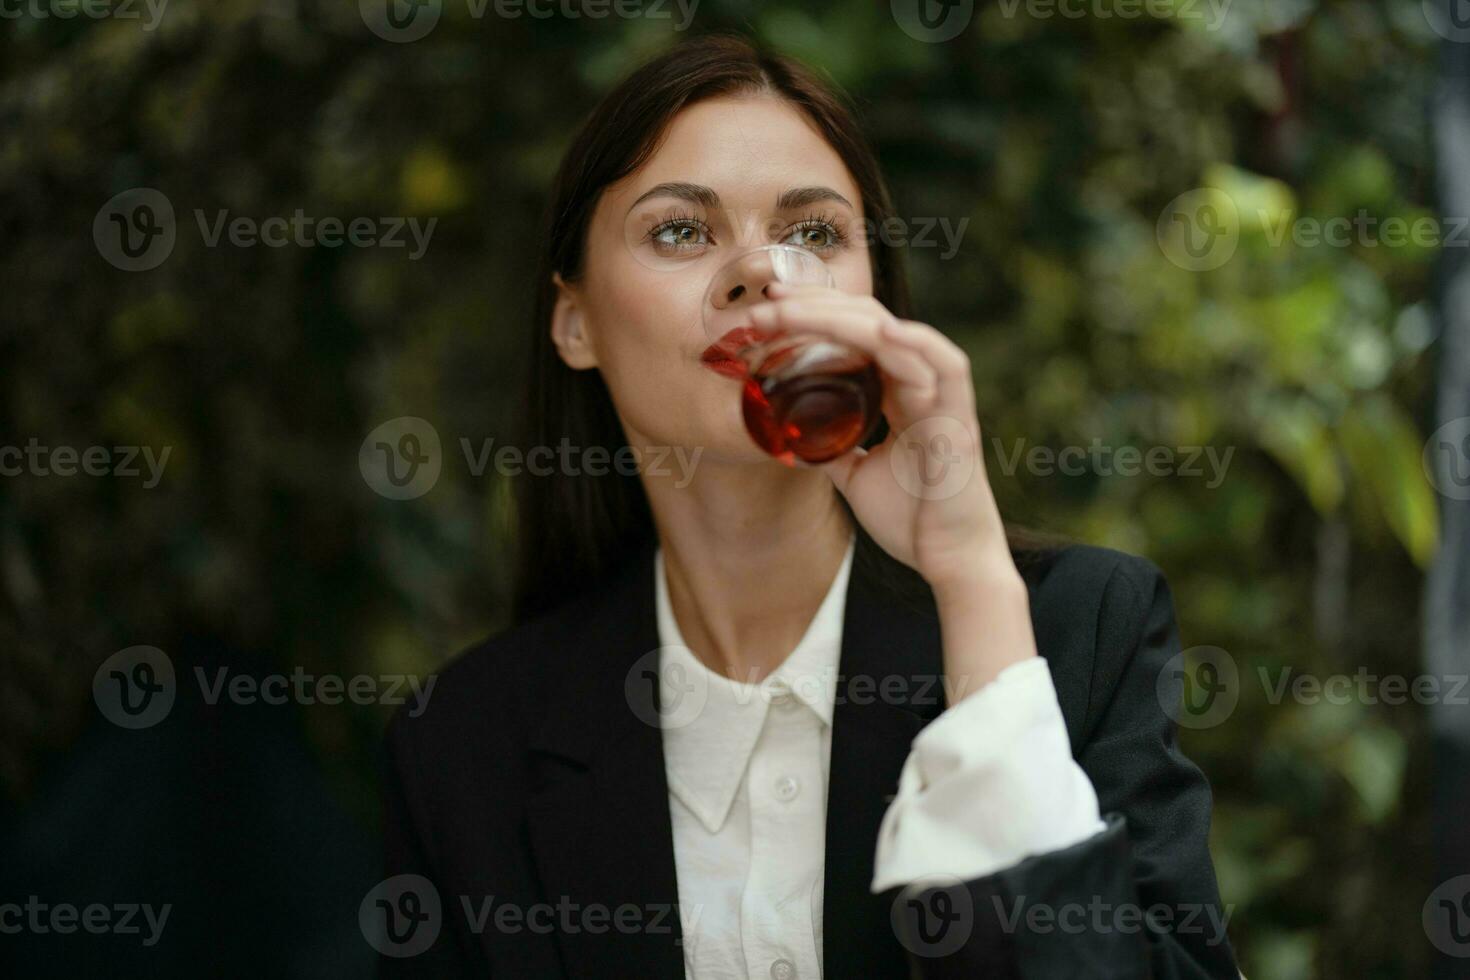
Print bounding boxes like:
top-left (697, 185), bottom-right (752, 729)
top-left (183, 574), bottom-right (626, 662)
top-left (822, 529), bottom-right (944, 977)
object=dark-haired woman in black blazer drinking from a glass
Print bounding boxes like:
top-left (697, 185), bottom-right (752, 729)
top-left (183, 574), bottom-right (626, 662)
top-left (379, 30), bottom-right (1236, 980)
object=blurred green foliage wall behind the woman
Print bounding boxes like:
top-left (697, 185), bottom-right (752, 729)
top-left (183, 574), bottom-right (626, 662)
top-left (0, 0), bottom-right (1438, 980)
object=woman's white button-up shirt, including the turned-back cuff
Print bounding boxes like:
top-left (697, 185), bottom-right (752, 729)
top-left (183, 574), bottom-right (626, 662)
top-left (654, 538), bottom-right (1104, 980)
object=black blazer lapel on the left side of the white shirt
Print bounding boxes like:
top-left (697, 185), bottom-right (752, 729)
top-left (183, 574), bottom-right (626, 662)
top-left (528, 545), bottom-right (684, 980)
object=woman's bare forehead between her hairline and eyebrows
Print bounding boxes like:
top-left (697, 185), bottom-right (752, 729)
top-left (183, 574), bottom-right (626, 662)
top-left (606, 96), bottom-right (863, 209)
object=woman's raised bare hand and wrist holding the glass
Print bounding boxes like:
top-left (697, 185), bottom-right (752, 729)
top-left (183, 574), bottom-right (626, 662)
top-left (751, 284), bottom-right (1036, 699)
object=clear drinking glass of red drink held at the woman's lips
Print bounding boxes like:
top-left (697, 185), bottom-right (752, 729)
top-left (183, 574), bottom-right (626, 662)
top-left (701, 245), bottom-right (883, 466)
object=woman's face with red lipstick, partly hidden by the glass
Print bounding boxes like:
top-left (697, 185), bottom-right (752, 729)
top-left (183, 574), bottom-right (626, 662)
top-left (553, 96), bottom-right (873, 466)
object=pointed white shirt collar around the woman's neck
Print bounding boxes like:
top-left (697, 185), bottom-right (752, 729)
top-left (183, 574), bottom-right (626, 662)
top-left (654, 535), bottom-right (857, 833)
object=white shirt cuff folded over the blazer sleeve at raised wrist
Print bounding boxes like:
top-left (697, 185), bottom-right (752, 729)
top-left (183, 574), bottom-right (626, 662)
top-left (872, 657), bottom-right (1105, 893)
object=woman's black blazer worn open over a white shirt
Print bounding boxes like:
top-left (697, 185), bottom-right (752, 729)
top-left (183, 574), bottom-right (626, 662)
top-left (376, 529), bottom-right (1238, 980)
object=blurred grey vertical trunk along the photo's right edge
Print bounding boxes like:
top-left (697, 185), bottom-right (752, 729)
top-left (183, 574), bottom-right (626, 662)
top-left (1424, 7), bottom-right (1470, 979)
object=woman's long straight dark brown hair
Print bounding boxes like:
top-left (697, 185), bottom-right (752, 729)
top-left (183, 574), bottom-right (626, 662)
top-left (512, 35), bottom-right (1052, 621)
